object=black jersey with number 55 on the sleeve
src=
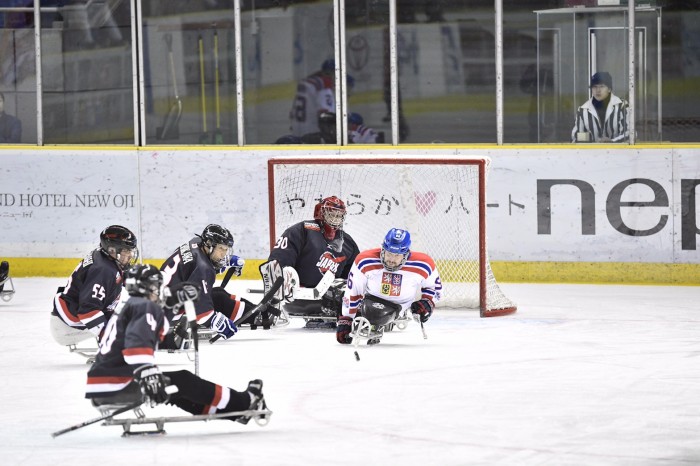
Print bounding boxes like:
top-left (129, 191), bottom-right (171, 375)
top-left (53, 248), bottom-right (124, 329)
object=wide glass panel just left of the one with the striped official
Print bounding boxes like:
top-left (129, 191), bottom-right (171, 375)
top-left (397, 0), bottom-right (496, 143)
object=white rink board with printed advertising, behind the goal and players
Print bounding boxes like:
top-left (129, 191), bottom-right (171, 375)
top-left (0, 148), bottom-right (700, 263)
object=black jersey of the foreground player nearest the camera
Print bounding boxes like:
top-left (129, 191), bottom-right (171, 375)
top-left (85, 296), bottom-right (169, 398)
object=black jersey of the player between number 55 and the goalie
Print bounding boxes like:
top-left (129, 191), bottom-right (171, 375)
top-left (160, 236), bottom-right (216, 325)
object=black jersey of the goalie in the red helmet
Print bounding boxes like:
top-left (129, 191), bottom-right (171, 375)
top-left (269, 220), bottom-right (360, 288)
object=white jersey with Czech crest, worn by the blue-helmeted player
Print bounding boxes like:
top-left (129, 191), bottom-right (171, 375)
top-left (343, 248), bottom-right (442, 317)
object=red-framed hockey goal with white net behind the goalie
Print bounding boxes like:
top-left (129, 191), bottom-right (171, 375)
top-left (268, 156), bottom-right (517, 317)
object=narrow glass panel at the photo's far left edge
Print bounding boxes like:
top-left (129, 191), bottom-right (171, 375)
top-left (0, 0), bottom-right (37, 144)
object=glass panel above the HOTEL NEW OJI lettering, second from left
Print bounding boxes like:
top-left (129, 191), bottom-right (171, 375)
top-left (41, 0), bottom-right (134, 144)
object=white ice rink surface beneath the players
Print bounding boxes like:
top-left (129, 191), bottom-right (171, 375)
top-left (0, 278), bottom-right (700, 466)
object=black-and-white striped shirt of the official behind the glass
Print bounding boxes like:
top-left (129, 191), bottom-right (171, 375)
top-left (571, 93), bottom-right (629, 142)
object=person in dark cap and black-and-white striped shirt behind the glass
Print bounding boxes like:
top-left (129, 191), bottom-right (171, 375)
top-left (571, 71), bottom-right (629, 142)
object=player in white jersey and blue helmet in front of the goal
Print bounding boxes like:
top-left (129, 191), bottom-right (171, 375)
top-left (336, 228), bottom-right (442, 344)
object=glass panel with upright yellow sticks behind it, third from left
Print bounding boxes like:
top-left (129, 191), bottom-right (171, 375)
top-left (142, 0), bottom-right (238, 144)
